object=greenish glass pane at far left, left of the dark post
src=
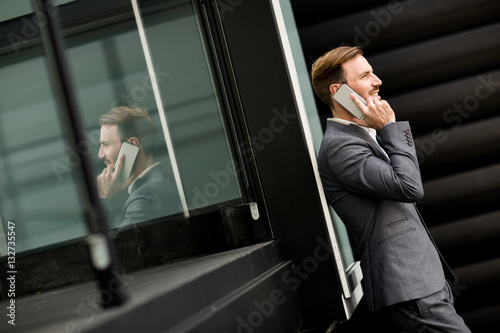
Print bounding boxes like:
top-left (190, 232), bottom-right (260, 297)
top-left (0, 47), bottom-right (86, 252)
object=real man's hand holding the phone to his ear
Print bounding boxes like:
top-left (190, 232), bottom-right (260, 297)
top-left (351, 94), bottom-right (396, 131)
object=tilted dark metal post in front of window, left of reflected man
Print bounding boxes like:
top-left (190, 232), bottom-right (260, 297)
top-left (33, 0), bottom-right (127, 307)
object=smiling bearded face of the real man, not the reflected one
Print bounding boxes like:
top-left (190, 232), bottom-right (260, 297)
top-left (342, 55), bottom-right (382, 100)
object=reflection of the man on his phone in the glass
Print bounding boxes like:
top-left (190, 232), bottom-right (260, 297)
top-left (97, 107), bottom-right (180, 227)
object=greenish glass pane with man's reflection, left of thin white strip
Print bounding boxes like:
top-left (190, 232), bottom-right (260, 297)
top-left (63, 21), bottom-right (186, 228)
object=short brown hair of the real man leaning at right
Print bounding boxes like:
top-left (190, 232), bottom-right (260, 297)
top-left (311, 46), bottom-right (363, 109)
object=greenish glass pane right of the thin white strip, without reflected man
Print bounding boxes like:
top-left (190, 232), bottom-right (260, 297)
top-left (143, 0), bottom-right (241, 209)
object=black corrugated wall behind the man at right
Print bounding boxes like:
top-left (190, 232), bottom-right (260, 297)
top-left (292, 0), bottom-right (500, 331)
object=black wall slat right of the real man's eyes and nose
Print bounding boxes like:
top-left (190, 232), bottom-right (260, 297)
top-left (367, 23), bottom-right (500, 95)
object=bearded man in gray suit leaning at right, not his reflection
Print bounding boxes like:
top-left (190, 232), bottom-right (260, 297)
top-left (312, 47), bottom-right (470, 332)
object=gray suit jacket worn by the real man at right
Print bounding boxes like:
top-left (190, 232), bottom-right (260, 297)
top-left (318, 121), bottom-right (454, 311)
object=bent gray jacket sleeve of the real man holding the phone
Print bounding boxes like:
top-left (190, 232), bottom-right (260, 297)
top-left (328, 122), bottom-right (424, 202)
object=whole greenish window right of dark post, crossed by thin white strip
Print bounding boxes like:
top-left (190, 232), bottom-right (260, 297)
top-left (63, 0), bottom-right (246, 227)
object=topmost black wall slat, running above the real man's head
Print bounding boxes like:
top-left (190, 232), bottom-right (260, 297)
top-left (300, 0), bottom-right (500, 55)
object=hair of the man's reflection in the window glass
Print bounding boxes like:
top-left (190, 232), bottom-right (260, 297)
top-left (99, 106), bottom-right (156, 156)
